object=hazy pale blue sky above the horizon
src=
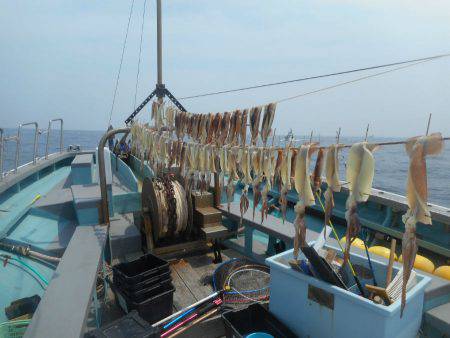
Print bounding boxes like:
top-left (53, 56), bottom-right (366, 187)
top-left (0, 0), bottom-right (450, 137)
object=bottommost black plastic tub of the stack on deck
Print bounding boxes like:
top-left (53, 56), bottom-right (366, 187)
top-left (113, 283), bottom-right (175, 324)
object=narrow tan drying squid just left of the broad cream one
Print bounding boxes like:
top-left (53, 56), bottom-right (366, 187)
top-left (324, 144), bottom-right (341, 235)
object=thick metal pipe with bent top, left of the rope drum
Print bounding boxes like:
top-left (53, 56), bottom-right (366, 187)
top-left (97, 128), bottom-right (130, 226)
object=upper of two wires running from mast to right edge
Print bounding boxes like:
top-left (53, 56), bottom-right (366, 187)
top-left (178, 53), bottom-right (450, 100)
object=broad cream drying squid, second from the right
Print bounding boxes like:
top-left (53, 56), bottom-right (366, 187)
top-left (344, 142), bottom-right (377, 264)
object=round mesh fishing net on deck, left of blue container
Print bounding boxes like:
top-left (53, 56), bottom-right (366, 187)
top-left (213, 259), bottom-right (270, 305)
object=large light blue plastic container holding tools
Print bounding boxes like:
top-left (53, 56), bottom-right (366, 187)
top-left (266, 248), bottom-right (431, 338)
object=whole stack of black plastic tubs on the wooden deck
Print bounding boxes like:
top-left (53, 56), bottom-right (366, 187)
top-left (113, 254), bottom-right (175, 324)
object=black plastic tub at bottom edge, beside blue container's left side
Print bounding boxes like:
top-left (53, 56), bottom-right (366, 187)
top-left (222, 304), bottom-right (297, 338)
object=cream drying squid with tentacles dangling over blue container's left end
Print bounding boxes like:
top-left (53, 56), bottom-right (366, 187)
top-left (294, 144), bottom-right (317, 259)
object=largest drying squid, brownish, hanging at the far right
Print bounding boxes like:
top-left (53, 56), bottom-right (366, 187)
top-left (400, 133), bottom-right (444, 316)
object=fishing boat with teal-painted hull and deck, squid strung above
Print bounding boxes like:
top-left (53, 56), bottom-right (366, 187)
top-left (0, 0), bottom-right (450, 337)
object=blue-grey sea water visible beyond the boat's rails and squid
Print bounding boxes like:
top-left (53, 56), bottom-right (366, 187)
top-left (4, 129), bottom-right (450, 207)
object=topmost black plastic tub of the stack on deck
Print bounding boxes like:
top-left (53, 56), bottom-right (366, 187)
top-left (112, 254), bottom-right (170, 286)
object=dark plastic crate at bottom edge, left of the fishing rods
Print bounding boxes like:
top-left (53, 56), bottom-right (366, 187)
top-left (86, 311), bottom-right (160, 338)
